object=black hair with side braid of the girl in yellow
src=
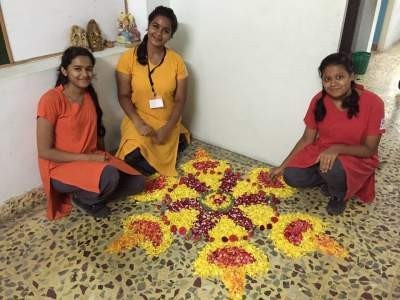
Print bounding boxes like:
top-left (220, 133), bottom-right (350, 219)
top-left (137, 6), bottom-right (178, 66)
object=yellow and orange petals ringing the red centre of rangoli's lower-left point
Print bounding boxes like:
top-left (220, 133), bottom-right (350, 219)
top-left (107, 214), bottom-right (172, 256)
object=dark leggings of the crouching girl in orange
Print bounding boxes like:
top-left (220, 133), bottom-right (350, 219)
top-left (51, 166), bottom-right (146, 205)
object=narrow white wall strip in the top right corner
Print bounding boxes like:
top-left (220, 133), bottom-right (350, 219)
top-left (378, 0), bottom-right (400, 51)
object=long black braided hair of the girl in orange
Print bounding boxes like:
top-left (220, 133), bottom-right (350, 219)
top-left (55, 47), bottom-right (106, 137)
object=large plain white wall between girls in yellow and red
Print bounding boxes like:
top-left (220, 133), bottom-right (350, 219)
top-left (170, 0), bottom-right (347, 165)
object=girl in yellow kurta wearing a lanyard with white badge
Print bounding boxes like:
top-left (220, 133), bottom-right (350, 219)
top-left (117, 6), bottom-right (189, 176)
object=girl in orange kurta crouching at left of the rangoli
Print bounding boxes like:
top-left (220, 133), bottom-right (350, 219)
top-left (37, 47), bottom-right (144, 219)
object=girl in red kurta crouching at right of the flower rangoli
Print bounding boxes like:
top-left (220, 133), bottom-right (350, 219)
top-left (270, 53), bottom-right (385, 215)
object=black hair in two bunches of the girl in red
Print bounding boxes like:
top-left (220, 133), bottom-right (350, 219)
top-left (314, 52), bottom-right (360, 122)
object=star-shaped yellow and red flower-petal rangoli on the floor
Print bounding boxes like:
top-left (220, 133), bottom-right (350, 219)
top-left (108, 150), bottom-right (347, 299)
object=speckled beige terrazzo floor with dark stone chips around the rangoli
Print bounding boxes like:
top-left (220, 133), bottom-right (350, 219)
top-left (0, 45), bottom-right (400, 300)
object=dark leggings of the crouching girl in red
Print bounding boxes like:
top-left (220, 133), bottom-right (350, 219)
top-left (283, 159), bottom-right (347, 199)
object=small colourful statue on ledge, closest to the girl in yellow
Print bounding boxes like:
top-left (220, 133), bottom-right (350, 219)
top-left (116, 12), bottom-right (140, 47)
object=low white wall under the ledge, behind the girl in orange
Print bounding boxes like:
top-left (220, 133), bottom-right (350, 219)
top-left (0, 48), bottom-right (125, 204)
